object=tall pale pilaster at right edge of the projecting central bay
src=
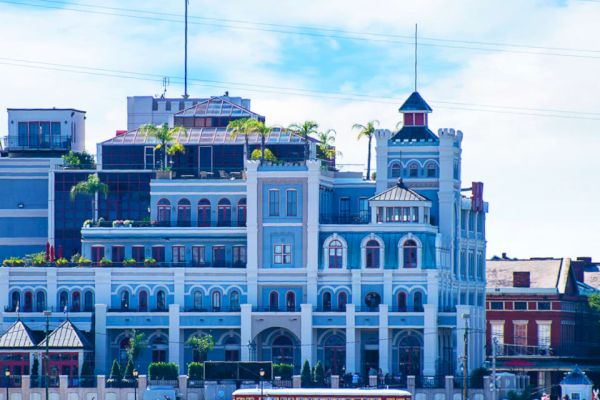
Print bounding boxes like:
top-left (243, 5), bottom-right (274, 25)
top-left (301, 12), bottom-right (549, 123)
top-left (305, 160), bottom-right (321, 306)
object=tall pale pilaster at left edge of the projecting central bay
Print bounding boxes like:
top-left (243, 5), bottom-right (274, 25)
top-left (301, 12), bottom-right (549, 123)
top-left (244, 160), bottom-right (260, 305)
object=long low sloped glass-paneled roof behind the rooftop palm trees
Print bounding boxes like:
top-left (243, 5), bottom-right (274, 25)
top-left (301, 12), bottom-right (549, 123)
top-left (102, 128), bottom-right (315, 145)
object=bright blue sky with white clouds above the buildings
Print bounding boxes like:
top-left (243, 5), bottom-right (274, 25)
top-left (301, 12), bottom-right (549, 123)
top-left (0, 0), bottom-right (600, 259)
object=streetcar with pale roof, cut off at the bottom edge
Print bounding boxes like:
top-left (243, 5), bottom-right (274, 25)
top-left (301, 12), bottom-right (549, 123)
top-left (233, 388), bottom-right (412, 400)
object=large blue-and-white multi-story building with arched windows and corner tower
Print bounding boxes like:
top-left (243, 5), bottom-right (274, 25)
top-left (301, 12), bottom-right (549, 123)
top-left (0, 92), bottom-right (487, 377)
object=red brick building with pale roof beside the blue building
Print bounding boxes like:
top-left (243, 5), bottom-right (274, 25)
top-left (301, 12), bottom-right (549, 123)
top-left (486, 256), bottom-right (600, 394)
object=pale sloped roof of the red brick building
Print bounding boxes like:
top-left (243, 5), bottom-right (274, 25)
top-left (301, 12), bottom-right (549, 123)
top-left (486, 258), bottom-right (571, 293)
